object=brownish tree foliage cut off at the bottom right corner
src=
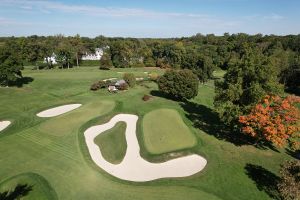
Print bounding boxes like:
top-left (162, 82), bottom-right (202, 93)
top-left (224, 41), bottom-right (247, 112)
top-left (278, 160), bottom-right (300, 200)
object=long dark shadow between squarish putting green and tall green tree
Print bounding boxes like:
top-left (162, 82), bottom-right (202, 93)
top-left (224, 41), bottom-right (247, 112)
top-left (180, 101), bottom-right (253, 146)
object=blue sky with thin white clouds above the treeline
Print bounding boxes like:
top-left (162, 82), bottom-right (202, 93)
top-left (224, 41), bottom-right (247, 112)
top-left (0, 0), bottom-right (300, 38)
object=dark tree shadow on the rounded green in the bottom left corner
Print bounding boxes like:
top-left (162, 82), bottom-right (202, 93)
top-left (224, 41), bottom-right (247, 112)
top-left (0, 184), bottom-right (33, 200)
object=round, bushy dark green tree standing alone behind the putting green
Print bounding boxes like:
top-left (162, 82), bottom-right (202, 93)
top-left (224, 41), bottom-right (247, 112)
top-left (157, 69), bottom-right (199, 100)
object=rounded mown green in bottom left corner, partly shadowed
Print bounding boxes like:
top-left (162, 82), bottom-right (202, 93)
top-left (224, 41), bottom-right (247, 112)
top-left (0, 173), bottom-right (58, 200)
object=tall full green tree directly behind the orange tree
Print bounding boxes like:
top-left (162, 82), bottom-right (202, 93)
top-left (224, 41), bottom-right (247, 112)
top-left (214, 44), bottom-right (283, 125)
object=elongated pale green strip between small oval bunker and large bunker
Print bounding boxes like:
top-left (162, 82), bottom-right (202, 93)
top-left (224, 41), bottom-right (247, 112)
top-left (39, 101), bottom-right (115, 136)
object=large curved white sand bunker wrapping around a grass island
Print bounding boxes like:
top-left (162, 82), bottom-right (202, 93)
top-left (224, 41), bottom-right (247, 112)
top-left (84, 114), bottom-right (207, 182)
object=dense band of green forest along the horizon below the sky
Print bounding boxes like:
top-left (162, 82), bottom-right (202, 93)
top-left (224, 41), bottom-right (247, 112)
top-left (0, 33), bottom-right (300, 92)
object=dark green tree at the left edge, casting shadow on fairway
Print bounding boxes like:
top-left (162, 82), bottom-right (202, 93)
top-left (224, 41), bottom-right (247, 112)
top-left (0, 42), bottom-right (23, 86)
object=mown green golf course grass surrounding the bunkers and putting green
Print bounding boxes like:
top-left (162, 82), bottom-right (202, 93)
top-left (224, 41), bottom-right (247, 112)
top-left (0, 67), bottom-right (292, 200)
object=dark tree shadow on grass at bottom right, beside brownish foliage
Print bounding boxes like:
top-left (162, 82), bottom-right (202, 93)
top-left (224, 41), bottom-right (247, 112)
top-left (245, 163), bottom-right (281, 199)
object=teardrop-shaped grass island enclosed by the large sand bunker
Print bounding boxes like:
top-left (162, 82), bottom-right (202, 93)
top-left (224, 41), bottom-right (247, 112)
top-left (94, 122), bottom-right (127, 164)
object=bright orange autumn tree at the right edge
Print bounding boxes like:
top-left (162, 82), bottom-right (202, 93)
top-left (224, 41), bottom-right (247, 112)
top-left (239, 95), bottom-right (300, 149)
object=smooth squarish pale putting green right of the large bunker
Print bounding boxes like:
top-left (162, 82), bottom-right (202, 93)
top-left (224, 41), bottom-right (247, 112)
top-left (143, 109), bottom-right (197, 154)
